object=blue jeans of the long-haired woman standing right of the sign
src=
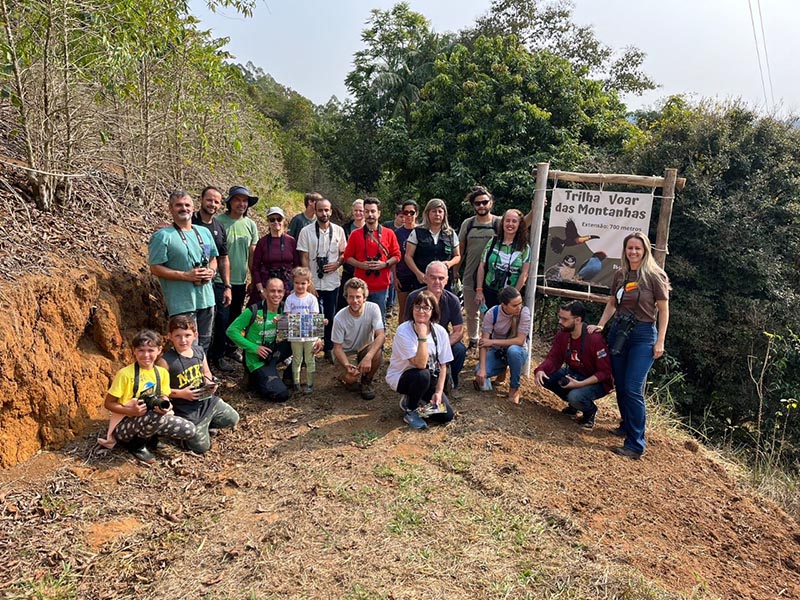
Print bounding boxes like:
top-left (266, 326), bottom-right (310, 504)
top-left (608, 323), bottom-right (657, 452)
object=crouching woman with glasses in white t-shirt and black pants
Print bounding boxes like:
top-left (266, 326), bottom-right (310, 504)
top-left (386, 290), bottom-right (453, 429)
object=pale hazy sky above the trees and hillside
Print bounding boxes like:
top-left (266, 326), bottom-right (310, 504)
top-left (191, 0), bottom-right (800, 116)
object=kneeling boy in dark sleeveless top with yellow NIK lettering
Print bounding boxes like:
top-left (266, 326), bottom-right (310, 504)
top-left (156, 315), bottom-right (239, 454)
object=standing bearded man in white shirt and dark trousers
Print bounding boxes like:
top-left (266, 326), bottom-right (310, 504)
top-left (297, 198), bottom-right (347, 364)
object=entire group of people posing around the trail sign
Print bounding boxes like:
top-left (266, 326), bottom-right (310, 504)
top-left (104, 186), bottom-right (668, 462)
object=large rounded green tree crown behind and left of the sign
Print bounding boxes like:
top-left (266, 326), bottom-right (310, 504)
top-left (380, 36), bottom-right (634, 218)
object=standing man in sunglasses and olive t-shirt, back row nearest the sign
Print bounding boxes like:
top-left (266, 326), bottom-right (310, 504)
top-left (458, 186), bottom-right (500, 348)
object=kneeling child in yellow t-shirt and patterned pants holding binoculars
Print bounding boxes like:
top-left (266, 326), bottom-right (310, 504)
top-left (101, 329), bottom-right (195, 463)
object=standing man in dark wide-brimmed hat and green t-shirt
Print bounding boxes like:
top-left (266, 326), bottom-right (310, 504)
top-left (209, 185), bottom-right (258, 371)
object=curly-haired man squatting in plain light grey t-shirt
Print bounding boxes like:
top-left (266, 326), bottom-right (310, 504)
top-left (331, 277), bottom-right (386, 400)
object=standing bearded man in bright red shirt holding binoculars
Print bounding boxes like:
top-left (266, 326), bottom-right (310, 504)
top-left (344, 198), bottom-right (400, 323)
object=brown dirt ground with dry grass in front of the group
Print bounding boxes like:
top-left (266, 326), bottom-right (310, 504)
top-left (0, 354), bottom-right (800, 599)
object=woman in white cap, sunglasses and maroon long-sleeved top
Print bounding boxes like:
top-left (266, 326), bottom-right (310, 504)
top-left (247, 206), bottom-right (301, 306)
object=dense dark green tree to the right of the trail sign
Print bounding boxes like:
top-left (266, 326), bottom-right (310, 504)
top-left (620, 97), bottom-right (800, 458)
